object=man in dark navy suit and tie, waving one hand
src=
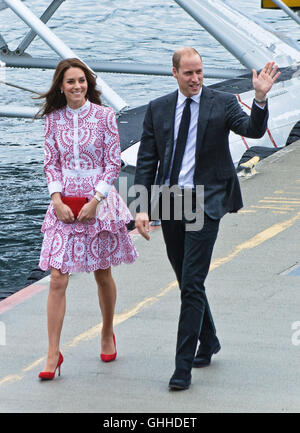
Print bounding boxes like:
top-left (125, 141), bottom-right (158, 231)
top-left (135, 47), bottom-right (280, 390)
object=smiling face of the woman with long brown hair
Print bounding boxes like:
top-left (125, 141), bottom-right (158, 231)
top-left (61, 67), bottom-right (88, 109)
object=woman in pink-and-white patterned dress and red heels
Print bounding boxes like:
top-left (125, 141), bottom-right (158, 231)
top-left (39, 59), bottom-right (137, 379)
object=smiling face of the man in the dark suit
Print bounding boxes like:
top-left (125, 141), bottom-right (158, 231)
top-left (173, 54), bottom-right (203, 98)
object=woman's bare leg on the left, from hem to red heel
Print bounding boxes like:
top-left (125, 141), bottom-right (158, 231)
top-left (43, 268), bottom-right (69, 372)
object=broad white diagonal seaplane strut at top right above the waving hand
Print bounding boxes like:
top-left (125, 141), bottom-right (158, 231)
top-left (175, 0), bottom-right (300, 69)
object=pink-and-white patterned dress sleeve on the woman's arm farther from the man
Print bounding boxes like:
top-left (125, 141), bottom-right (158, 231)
top-left (44, 114), bottom-right (63, 196)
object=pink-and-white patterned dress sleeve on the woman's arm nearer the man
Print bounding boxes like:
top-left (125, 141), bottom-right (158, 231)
top-left (96, 108), bottom-right (121, 197)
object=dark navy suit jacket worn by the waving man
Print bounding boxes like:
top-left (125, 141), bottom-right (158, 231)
top-left (135, 86), bottom-right (268, 219)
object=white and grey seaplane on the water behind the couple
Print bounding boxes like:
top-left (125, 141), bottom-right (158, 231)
top-left (0, 0), bottom-right (300, 183)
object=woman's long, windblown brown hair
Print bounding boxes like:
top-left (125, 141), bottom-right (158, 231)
top-left (35, 58), bottom-right (102, 118)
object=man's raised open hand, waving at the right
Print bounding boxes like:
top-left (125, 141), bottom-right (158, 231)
top-left (252, 62), bottom-right (280, 101)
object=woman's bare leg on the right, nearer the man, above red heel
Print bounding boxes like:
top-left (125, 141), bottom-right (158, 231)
top-left (94, 268), bottom-right (117, 355)
